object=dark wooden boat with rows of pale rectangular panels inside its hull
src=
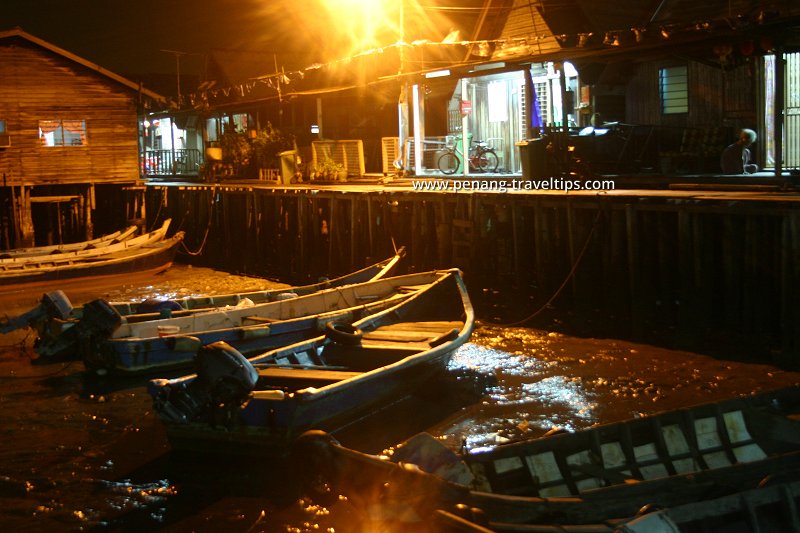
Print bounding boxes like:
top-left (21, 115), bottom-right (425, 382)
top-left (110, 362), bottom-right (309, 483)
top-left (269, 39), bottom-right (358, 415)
top-left (298, 387), bottom-right (800, 531)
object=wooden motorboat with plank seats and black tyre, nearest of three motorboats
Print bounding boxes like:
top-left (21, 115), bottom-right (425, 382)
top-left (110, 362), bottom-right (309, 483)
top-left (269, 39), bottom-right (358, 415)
top-left (148, 270), bottom-right (475, 456)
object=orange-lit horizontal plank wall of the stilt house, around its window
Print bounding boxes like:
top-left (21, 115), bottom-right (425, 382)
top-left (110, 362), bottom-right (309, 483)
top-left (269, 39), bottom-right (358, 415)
top-left (0, 38), bottom-right (139, 185)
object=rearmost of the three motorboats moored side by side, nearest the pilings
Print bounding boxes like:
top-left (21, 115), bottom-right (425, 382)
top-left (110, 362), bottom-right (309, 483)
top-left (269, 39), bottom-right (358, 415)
top-left (0, 247), bottom-right (405, 358)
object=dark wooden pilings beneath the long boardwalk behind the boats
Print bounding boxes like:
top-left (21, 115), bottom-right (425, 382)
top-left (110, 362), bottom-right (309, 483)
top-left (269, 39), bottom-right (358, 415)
top-left (147, 185), bottom-right (800, 364)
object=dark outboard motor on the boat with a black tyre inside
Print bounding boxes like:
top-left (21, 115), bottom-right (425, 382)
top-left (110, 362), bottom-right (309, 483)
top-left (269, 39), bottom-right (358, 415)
top-left (151, 341), bottom-right (258, 425)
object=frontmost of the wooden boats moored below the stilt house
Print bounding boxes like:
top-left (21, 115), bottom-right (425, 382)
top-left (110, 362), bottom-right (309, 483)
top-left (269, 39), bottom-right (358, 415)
top-left (0, 231), bottom-right (184, 289)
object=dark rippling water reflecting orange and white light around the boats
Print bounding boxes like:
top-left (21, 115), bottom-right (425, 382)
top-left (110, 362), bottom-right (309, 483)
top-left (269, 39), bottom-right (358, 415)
top-left (0, 266), bottom-right (800, 533)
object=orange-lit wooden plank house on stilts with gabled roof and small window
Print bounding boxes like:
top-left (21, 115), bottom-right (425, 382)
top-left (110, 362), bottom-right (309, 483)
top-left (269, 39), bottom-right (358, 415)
top-left (0, 29), bottom-right (165, 249)
